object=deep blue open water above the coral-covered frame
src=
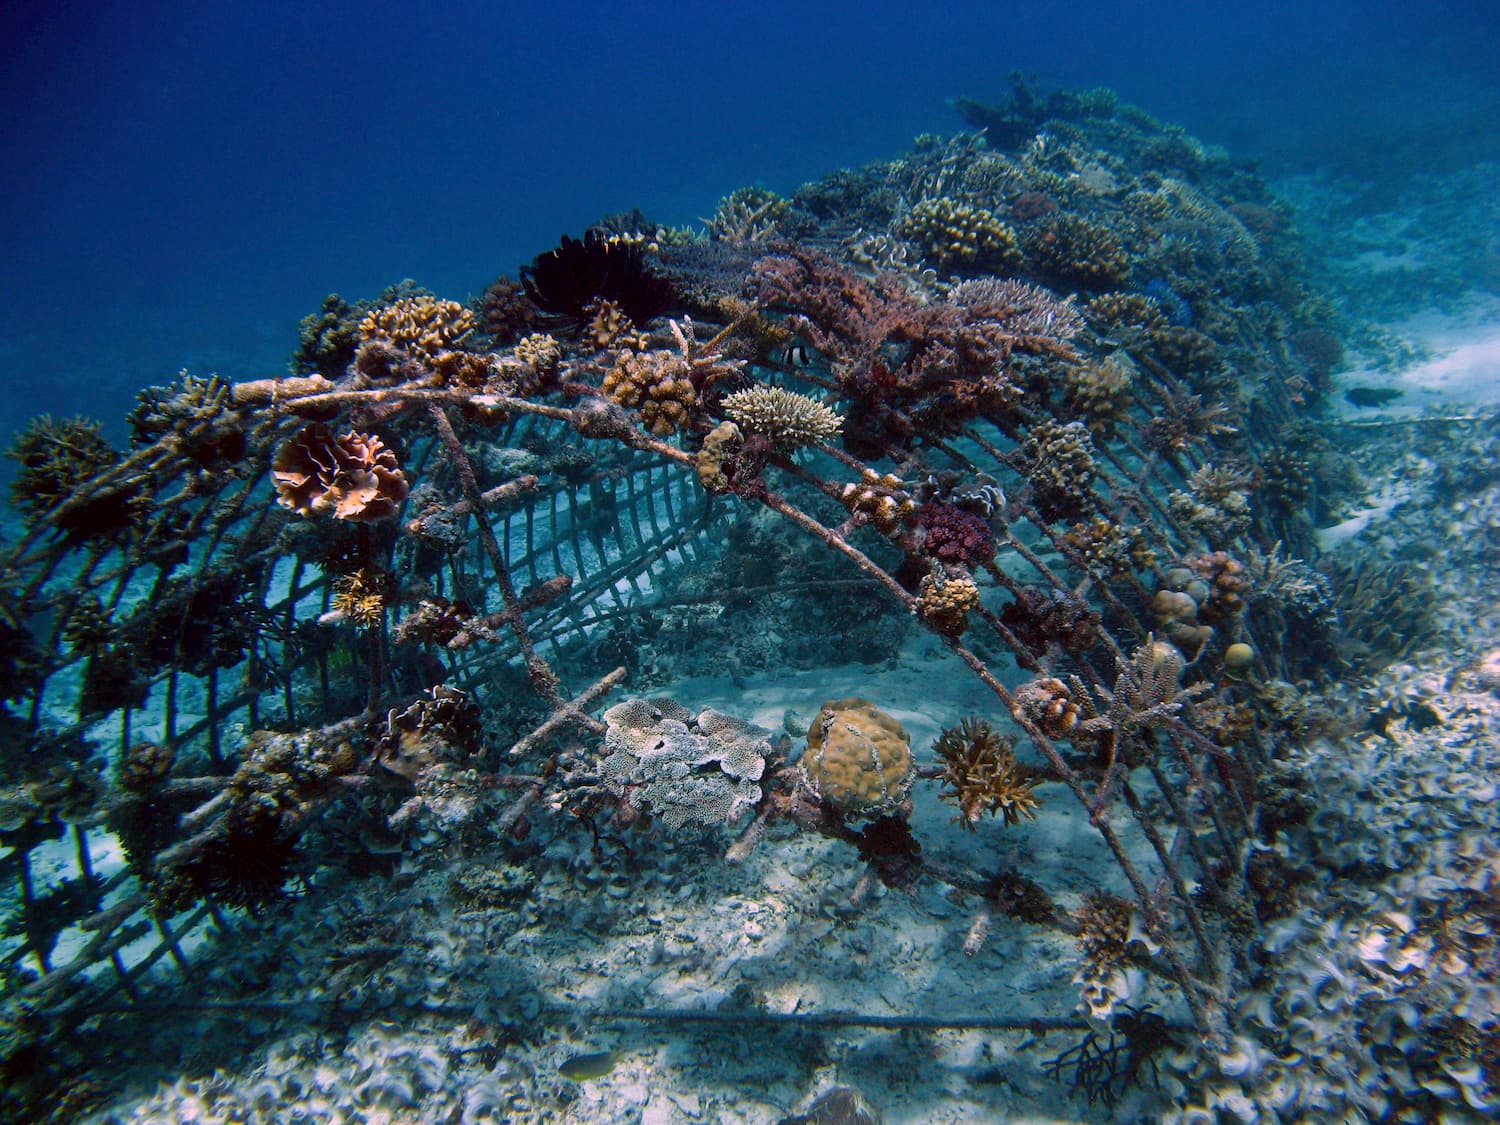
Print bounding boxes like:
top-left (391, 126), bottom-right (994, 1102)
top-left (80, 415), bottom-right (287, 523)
top-left (0, 0), bottom-right (1500, 434)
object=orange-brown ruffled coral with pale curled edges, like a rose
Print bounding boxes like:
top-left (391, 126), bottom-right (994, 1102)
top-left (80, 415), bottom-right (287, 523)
top-left (272, 425), bottom-right (407, 524)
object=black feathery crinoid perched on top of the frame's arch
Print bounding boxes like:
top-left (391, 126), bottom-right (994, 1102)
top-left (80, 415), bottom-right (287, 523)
top-left (521, 230), bottom-right (674, 332)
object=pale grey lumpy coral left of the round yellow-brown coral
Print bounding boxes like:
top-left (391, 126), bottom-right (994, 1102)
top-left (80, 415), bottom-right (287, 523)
top-left (600, 699), bottom-right (771, 828)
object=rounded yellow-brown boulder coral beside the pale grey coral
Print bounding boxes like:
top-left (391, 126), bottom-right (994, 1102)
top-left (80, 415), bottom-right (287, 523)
top-left (803, 698), bottom-right (915, 816)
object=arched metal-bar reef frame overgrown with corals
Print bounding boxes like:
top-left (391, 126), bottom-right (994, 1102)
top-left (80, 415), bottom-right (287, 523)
top-left (0, 83), bottom-right (1356, 1116)
